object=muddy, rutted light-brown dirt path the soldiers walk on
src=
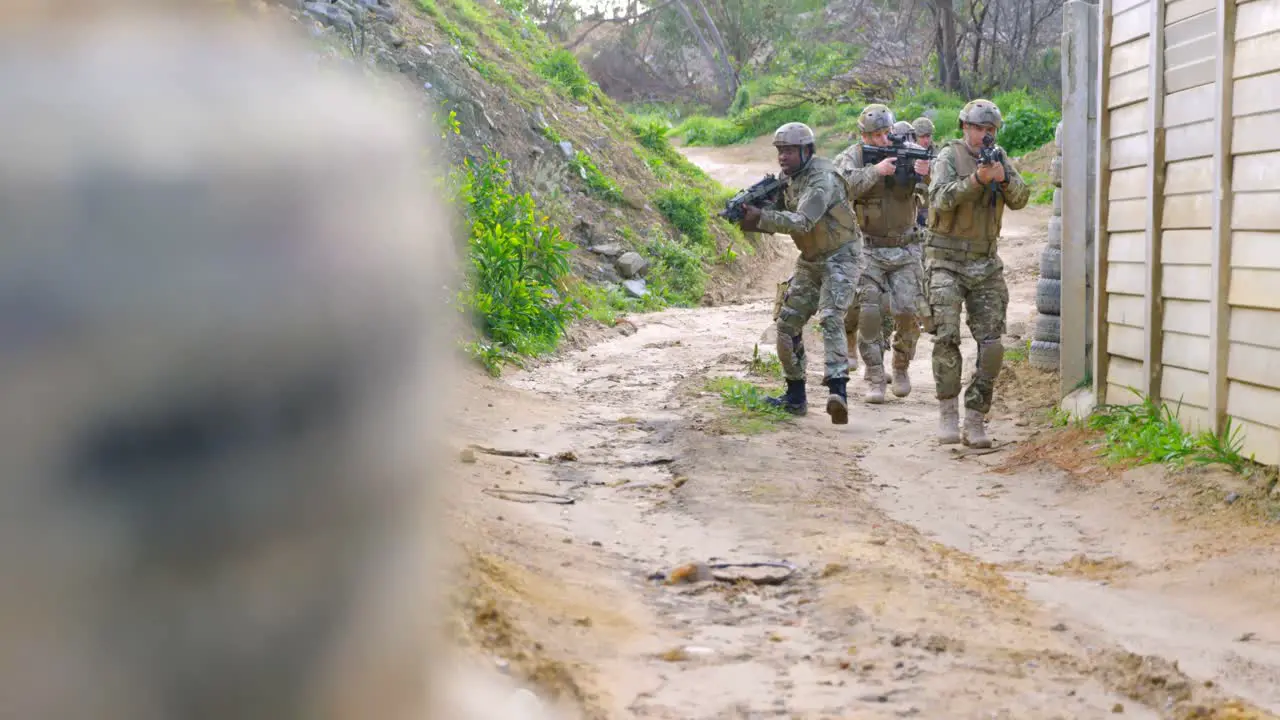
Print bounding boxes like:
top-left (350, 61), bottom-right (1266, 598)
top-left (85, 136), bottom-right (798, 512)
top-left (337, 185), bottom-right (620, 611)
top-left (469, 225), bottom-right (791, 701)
top-left (454, 137), bottom-right (1280, 720)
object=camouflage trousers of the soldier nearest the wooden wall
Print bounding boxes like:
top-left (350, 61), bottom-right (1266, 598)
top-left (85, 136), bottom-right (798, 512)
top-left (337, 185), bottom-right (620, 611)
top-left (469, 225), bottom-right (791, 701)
top-left (929, 258), bottom-right (1009, 414)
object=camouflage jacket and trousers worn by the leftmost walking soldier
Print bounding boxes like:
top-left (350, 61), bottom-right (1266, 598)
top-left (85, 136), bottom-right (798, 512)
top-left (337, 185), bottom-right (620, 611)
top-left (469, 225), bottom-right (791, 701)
top-left (759, 158), bottom-right (861, 382)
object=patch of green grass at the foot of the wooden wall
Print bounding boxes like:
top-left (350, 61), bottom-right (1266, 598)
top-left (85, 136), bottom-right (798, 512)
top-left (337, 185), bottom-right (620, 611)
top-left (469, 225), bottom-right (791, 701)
top-left (1087, 388), bottom-right (1254, 473)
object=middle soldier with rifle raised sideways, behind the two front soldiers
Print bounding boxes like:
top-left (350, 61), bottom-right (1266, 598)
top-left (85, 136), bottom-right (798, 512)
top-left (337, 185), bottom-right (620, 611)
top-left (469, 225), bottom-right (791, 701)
top-left (835, 104), bottom-right (929, 404)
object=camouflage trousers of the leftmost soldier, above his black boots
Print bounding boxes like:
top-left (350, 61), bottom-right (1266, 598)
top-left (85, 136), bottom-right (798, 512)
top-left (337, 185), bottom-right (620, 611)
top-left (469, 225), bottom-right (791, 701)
top-left (778, 241), bottom-right (860, 380)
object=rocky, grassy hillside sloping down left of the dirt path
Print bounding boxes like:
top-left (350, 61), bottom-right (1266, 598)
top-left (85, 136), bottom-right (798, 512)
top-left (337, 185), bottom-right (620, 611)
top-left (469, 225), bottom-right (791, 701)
top-left (294, 0), bottom-right (753, 373)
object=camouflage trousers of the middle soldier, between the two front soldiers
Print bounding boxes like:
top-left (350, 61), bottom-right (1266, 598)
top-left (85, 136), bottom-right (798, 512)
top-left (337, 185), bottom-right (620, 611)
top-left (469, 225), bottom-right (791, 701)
top-left (845, 245), bottom-right (928, 368)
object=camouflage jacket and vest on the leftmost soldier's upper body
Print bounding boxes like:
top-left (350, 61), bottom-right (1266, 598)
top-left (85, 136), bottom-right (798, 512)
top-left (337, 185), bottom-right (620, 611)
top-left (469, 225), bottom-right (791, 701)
top-left (758, 158), bottom-right (858, 260)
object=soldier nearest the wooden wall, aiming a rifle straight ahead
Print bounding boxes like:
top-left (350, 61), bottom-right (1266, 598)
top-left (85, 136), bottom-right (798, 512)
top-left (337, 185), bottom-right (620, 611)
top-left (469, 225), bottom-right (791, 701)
top-left (925, 100), bottom-right (1029, 447)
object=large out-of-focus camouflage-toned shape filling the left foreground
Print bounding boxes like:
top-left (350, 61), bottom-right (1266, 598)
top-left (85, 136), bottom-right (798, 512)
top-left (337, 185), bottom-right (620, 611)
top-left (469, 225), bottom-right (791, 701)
top-left (0, 0), bottom-right (550, 720)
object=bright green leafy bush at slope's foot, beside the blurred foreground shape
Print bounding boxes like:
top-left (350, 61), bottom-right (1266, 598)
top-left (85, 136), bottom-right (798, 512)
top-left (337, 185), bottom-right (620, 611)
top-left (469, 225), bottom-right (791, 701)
top-left (454, 146), bottom-right (576, 372)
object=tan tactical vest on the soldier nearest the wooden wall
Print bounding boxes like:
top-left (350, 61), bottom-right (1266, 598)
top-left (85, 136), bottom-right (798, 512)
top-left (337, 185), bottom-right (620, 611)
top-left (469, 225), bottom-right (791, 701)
top-left (929, 140), bottom-right (1005, 263)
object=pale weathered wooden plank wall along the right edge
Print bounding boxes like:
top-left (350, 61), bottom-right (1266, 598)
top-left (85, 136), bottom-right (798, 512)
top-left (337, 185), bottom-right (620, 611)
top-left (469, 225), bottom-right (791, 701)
top-left (1092, 0), bottom-right (1280, 464)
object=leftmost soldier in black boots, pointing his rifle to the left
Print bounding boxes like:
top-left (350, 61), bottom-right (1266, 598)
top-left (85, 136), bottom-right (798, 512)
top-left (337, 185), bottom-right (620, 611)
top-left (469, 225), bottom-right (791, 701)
top-left (741, 123), bottom-right (860, 425)
